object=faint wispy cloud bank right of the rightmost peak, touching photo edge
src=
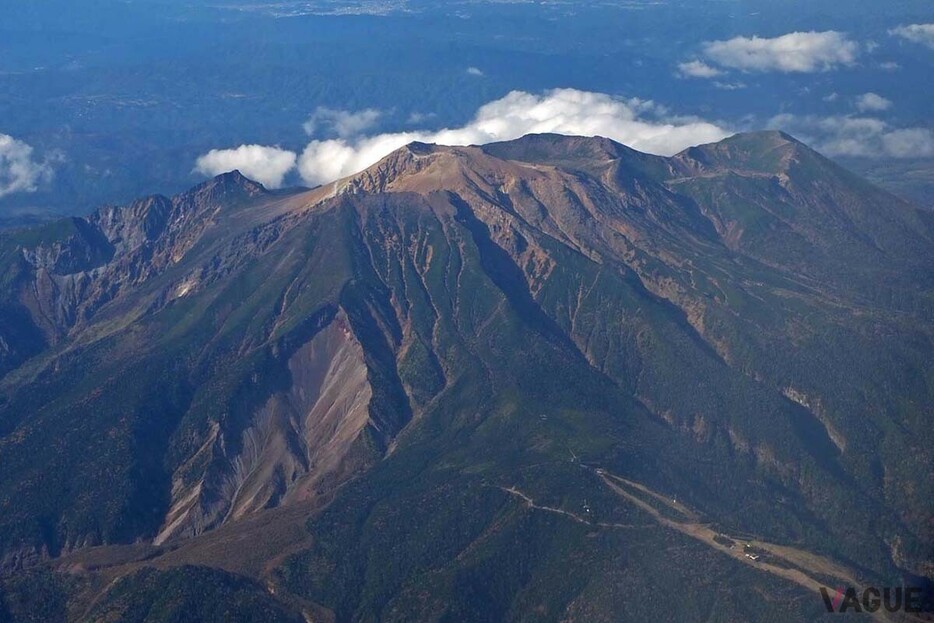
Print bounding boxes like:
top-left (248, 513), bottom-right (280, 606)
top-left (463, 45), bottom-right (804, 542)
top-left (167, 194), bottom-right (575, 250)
top-left (768, 114), bottom-right (934, 158)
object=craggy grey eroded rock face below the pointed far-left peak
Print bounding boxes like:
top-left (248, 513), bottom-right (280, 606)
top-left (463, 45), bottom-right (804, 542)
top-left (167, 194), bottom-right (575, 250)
top-left (3, 172), bottom-right (266, 343)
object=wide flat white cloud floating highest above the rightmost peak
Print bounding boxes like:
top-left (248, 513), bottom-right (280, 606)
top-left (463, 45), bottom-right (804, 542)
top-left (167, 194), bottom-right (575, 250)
top-left (703, 30), bottom-right (859, 73)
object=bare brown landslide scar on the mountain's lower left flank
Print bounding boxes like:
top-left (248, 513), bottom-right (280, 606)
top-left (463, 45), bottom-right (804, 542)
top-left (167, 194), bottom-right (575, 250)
top-left (154, 314), bottom-right (373, 545)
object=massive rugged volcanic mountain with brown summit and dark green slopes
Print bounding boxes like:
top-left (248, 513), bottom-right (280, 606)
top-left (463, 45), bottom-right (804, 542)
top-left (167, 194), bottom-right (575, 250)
top-left (0, 132), bottom-right (934, 621)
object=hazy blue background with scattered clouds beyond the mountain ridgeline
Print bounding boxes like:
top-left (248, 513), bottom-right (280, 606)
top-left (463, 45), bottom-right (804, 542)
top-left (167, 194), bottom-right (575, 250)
top-left (0, 0), bottom-right (934, 219)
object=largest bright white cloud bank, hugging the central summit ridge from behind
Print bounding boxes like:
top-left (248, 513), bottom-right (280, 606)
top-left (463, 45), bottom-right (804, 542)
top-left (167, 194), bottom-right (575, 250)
top-left (298, 89), bottom-right (730, 184)
